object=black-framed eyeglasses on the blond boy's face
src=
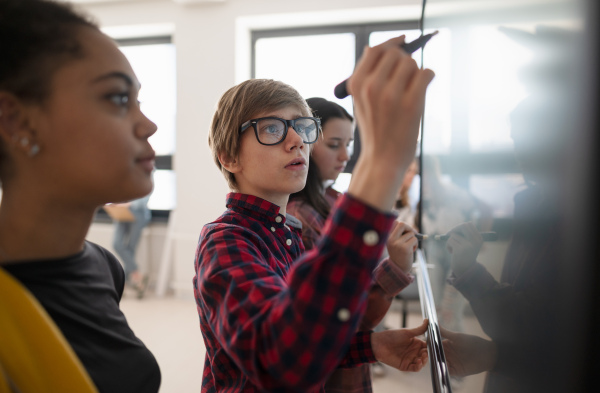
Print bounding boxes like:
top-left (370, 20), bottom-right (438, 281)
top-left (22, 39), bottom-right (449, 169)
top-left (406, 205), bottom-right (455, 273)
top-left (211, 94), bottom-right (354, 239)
top-left (240, 117), bottom-right (321, 146)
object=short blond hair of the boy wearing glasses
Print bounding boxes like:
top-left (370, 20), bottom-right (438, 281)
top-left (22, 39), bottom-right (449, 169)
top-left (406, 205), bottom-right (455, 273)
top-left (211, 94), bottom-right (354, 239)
top-left (208, 79), bottom-right (311, 190)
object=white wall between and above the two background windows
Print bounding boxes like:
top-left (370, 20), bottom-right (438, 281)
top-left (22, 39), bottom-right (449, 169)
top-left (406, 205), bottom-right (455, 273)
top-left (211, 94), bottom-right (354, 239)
top-left (82, 0), bottom-right (421, 297)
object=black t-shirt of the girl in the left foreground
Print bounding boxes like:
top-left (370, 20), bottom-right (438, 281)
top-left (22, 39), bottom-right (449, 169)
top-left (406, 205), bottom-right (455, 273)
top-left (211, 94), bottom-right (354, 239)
top-left (2, 242), bottom-right (160, 393)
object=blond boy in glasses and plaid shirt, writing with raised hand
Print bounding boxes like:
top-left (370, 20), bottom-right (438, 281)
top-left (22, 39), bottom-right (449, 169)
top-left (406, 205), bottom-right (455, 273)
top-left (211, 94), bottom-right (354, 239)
top-left (194, 38), bottom-right (433, 392)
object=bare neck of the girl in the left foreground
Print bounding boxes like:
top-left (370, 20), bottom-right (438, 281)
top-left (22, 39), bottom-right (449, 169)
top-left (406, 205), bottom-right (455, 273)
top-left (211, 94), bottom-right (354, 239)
top-left (0, 190), bottom-right (95, 264)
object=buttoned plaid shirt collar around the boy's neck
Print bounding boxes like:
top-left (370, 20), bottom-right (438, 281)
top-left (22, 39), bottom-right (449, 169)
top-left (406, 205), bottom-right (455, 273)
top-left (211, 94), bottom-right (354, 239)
top-left (226, 192), bottom-right (302, 229)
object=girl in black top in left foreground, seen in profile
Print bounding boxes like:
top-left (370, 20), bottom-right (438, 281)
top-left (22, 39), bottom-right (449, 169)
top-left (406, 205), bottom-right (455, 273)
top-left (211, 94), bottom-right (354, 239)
top-left (0, 0), bottom-right (160, 393)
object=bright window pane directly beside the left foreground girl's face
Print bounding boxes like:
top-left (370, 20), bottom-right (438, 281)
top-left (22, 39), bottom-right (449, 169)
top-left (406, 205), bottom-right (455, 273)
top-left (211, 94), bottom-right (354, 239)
top-left (120, 44), bottom-right (177, 155)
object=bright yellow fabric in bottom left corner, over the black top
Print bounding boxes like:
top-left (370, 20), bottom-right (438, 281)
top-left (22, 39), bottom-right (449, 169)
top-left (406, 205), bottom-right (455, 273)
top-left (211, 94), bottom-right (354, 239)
top-left (0, 268), bottom-right (98, 393)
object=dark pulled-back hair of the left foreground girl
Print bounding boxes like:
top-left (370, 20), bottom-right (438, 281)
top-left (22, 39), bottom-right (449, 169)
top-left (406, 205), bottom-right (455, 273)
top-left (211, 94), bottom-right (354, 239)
top-left (0, 0), bottom-right (98, 176)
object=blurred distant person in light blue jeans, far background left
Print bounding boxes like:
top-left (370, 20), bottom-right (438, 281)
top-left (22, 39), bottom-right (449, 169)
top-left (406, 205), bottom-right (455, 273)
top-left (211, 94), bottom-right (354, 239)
top-left (105, 195), bottom-right (152, 299)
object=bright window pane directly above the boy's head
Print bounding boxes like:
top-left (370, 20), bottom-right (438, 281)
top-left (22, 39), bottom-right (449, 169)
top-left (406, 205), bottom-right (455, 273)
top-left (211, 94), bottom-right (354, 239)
top-left (255, 33), bottom-right (356, 113)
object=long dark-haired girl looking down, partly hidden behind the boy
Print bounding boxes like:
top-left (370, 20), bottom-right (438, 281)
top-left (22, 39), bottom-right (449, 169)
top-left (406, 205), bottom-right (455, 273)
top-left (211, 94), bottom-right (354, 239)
top-left (287, 98), bottom-right (417, 393)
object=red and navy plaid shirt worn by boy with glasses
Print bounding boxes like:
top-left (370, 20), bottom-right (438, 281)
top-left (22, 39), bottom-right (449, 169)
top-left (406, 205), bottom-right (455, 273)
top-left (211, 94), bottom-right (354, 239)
top-left (194, 193), bottom-right (394, 392)
